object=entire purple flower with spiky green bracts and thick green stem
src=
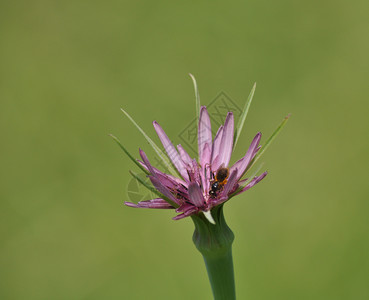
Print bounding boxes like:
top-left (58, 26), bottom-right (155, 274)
top-left (112, 78), bottom-right (289, 300)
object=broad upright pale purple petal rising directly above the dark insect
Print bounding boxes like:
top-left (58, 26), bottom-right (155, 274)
top-left (213, 112), bottom-right (234, 170)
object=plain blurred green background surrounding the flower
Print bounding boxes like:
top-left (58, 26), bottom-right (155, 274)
top-left (0, 0), bottom-right (369, 300)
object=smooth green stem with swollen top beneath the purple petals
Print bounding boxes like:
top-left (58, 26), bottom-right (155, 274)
top-left (192, 205), bottom-right (236, 300)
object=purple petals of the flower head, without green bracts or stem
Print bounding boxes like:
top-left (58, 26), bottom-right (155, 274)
top-left (125, 106), bottom-right (267, 222)
